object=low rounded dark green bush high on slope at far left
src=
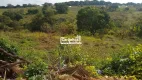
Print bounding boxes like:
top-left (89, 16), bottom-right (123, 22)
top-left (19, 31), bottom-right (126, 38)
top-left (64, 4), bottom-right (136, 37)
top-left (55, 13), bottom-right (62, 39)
top-left (3, 11), bottom-right (23, 21)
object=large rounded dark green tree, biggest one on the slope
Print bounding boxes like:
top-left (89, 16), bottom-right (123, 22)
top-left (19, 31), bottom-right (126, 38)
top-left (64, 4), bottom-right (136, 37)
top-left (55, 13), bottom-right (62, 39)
top-left (77, 7), bottom-right (110, 34)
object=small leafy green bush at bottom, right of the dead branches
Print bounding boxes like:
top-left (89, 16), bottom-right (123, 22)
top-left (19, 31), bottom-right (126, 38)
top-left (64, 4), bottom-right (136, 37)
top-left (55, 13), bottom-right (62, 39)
top-left (25, 58), bottom-right (48, 78)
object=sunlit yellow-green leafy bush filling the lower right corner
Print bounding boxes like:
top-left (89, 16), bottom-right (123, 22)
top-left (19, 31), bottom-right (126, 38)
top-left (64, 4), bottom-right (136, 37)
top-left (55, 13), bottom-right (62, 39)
top-left (102, 45), bottom-right (142, 79)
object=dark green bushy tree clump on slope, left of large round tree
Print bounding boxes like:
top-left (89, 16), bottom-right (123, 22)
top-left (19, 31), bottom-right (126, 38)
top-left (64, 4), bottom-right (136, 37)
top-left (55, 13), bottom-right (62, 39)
top-left (29, 11), bottom-right (54, 32)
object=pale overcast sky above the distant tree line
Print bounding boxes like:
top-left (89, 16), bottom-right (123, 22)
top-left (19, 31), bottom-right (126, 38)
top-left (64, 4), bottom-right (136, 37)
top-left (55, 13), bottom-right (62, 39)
top-left (0, 0), bottom-right (142, 6)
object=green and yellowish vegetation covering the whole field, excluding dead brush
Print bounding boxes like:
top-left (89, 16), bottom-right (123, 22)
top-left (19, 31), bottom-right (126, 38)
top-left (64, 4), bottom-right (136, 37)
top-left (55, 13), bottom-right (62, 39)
top-left (0, 0), bottom-right (142, 80)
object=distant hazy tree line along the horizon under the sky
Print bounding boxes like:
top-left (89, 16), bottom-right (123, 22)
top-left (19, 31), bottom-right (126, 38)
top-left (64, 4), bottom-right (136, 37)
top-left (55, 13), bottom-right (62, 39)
top-left (0, 0), bottom-right (142, 8)
